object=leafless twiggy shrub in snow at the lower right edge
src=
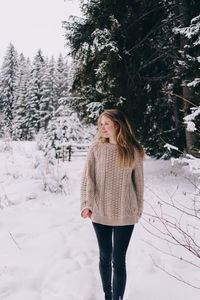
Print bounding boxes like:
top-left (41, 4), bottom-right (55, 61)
top-left (142, 174), bottom-right (200, 289)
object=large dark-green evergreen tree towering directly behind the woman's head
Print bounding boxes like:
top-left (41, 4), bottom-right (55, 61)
top-left (64, 0), bottom-right (183, 157)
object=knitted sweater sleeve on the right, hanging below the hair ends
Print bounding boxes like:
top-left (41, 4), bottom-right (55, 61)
top-left (133, 153), bottom-right (144, 216)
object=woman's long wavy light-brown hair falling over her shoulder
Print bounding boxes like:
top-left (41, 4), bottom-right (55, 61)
top-left (95, 109), bottom-right (145, 168)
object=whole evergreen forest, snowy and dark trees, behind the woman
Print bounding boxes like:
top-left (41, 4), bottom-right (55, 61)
top-left (0, 0), bottom-right (200, 159)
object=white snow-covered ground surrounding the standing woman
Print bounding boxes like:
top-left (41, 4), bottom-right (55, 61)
top-left (0, 142), bottom-right (200, 300)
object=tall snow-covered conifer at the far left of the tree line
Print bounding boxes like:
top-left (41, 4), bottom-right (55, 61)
top-left (0, 43), bottom-right (18, 135)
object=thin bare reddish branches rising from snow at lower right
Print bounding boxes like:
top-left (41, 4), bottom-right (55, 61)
top-left (141, 178), bottom-right (200, 289)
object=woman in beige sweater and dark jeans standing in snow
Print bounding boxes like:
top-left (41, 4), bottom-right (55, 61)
top-left (81, 109), bottom-right (145, 300)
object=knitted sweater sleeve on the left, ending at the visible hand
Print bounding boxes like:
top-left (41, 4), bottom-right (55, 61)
top-left (80, 143), bottom-right (96, 213)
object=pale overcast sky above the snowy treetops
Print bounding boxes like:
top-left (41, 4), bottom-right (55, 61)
top-left (0, 0), bottom-right (80, 66)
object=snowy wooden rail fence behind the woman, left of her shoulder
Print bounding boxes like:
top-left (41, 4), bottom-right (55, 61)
top-left (56, 144), bottom-right (90, 162)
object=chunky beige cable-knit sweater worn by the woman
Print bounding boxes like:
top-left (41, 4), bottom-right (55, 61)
top-left (80, 141), bottom-right (144, 226)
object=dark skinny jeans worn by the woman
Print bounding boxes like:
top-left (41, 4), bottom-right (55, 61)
top-left (92, 222), bottom-right (134, 300)
